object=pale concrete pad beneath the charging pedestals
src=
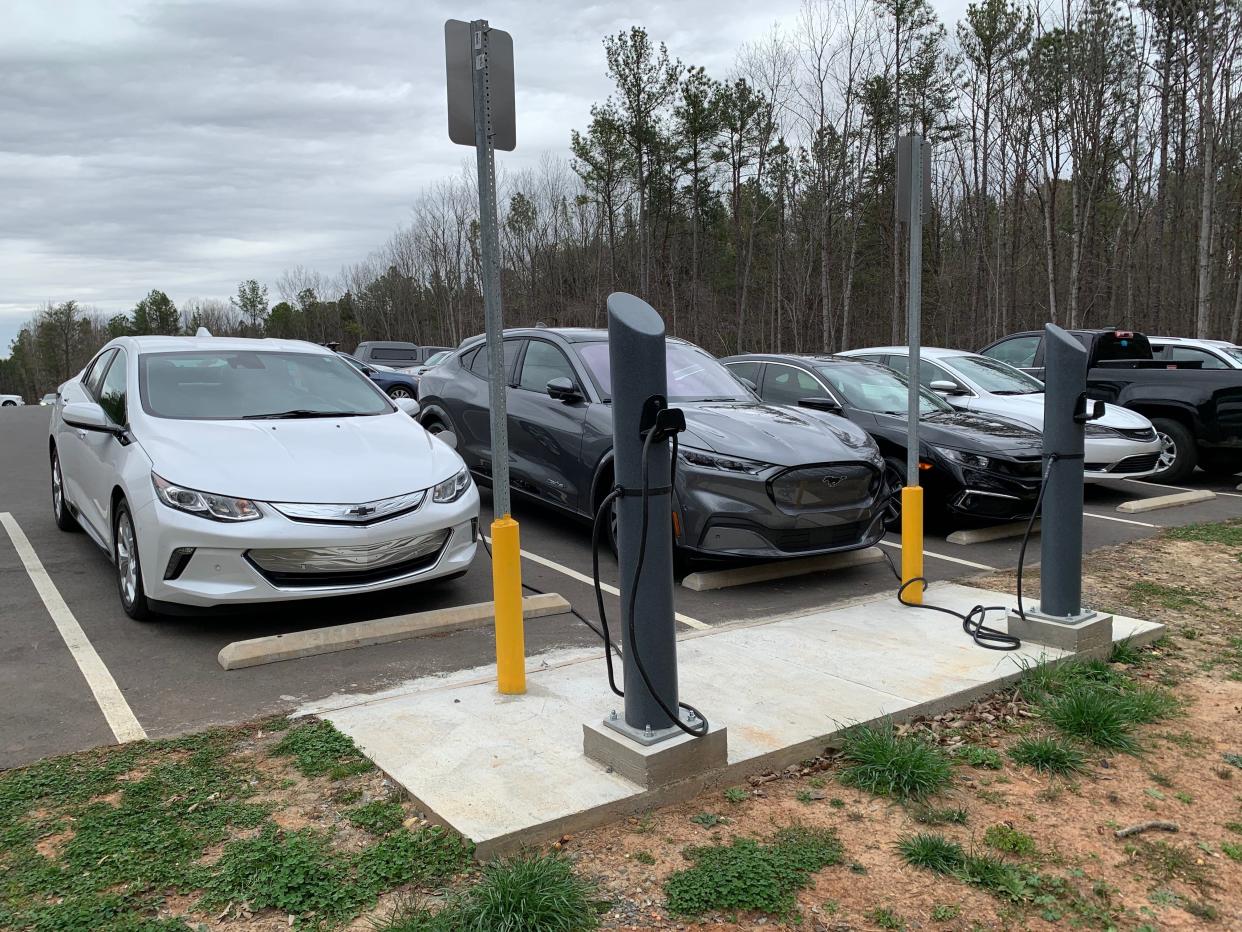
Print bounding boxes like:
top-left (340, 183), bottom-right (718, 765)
top-left (324, 584), bottom-right (1164, 859)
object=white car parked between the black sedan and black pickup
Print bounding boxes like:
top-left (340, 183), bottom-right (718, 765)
top-left (841, 347), bottom-right (1161, 481)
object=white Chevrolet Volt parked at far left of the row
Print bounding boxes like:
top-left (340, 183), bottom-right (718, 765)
top-left (48, 331), bottom-right (478, 619)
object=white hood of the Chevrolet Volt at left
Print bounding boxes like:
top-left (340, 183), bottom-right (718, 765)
top-left (134, 411), bottom-right (462, 503)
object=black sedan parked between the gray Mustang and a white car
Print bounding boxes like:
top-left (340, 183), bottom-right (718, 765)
top-left (722, 353), bottom-right (1043, 527)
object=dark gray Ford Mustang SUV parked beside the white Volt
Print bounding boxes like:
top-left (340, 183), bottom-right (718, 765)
top-left (420, 328), bottom-right (889, 558)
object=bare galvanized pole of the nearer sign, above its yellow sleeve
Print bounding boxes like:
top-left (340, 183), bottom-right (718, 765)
top-left (469, 20), bottom-right (510, 517)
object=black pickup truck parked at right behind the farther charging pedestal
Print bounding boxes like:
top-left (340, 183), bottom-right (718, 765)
top-left (979, 329), bottom-right (1242, 482)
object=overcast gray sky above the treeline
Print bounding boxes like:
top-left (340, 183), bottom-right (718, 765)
top-left (0, 0), bottom-right (965, 355)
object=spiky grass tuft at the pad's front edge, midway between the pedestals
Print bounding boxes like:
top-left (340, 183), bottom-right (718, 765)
top-left (841, 722), bottom-right (953, 800)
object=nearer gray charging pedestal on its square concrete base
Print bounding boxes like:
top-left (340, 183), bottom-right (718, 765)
top-left (582, 292), bottom-right (727, 787)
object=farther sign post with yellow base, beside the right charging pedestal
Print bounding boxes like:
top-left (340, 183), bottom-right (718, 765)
top-left (897, 135), bottom-right (925, 603)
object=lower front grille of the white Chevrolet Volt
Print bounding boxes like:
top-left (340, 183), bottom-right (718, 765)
top-left (246, 529), bottom-right (450, 587)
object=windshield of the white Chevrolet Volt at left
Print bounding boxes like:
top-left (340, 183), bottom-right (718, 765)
top-left (138, 349), bottom-right (392, 420)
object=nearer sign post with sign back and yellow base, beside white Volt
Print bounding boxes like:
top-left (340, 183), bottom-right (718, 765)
top-left (445, 20), bottom-right (527, 693)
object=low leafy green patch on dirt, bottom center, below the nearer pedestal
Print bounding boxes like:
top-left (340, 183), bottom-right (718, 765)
top-left (664, 825), bottom-right (843, 916)
